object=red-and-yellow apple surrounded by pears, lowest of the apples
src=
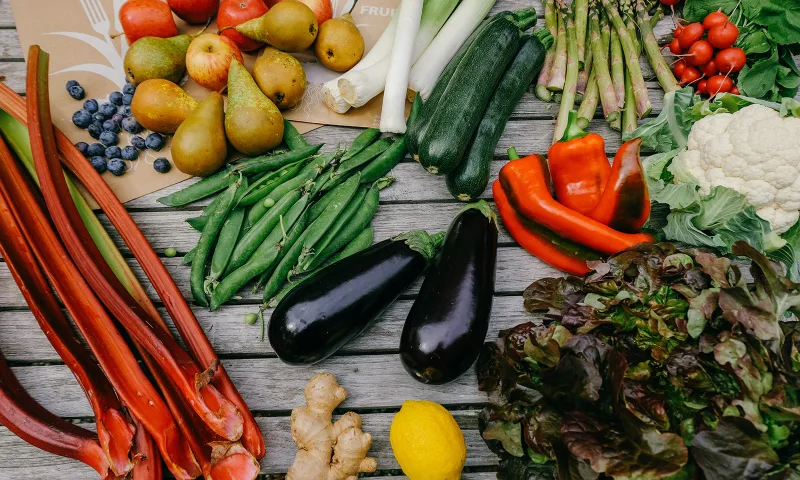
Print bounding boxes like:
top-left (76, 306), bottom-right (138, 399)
top-left (186, 33), bottom-right (242, 92)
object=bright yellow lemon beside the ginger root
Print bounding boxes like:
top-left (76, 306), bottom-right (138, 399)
top-left (389, 400), bottom-right (467, 480)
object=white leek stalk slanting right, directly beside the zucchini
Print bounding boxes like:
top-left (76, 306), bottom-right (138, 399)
top-left (408, 0), bottom-right (496, 100)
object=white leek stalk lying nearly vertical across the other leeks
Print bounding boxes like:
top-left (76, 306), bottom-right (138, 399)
top-left (381, 0), bottom-right (422, 133)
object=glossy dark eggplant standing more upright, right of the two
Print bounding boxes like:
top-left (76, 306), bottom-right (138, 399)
top-left (400, 201), bottom-right (497, 385)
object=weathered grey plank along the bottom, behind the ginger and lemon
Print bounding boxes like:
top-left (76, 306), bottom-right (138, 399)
top-left (0, 410), bottom-right (497, 480)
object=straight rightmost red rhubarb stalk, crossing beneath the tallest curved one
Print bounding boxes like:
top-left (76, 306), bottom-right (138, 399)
top-left (0, 74), bottom-right (265, 458)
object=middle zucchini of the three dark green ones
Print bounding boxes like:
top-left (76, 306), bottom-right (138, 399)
top-left (417, 9), bottom-right (536, 174)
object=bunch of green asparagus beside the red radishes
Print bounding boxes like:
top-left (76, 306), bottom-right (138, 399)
top-left (536, 0), bottom-right (679, 142)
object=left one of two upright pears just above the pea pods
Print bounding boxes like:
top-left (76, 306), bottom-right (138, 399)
top-left (172, 92), bottom-right (228, 177)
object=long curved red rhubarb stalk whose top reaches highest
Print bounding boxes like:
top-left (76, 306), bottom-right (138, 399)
top-left (27, 45), bottom-right (243, 440)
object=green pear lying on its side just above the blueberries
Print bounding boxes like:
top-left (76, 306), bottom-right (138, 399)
top-left (125, 31), bottom-right (195, 85)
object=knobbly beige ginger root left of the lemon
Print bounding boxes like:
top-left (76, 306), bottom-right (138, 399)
top-left (286, 373), bottom-right (378, 480)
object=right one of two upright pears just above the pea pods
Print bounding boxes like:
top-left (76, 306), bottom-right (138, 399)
top-left (225, 59), bottom-right (283, 155)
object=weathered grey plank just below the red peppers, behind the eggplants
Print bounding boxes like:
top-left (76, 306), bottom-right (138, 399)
top-left (0, 246), bottom-right (563, 306)
